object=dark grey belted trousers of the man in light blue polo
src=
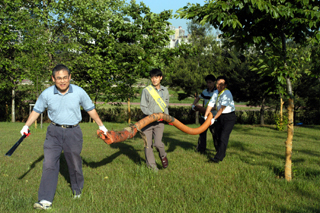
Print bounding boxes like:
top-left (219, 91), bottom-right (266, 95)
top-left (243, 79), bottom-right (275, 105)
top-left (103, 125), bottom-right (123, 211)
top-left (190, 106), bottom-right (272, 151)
top-left (38, 124), bottom-right (84, 202)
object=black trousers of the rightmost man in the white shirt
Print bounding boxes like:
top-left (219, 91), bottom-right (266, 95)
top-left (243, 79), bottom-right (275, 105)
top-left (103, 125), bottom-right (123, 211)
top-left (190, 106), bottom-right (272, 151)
top-left (214, 112), bottom-right (237, 161)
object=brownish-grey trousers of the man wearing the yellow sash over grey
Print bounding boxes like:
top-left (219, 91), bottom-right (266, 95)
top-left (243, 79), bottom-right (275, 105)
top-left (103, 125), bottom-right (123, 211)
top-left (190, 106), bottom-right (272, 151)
top-left (142, 122), bottom-right (167, 168)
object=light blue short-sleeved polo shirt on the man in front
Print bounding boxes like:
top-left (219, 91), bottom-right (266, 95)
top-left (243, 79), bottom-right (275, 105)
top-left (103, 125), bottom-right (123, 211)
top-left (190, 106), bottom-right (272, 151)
top-left (33, 84), bottom-right (95, 125)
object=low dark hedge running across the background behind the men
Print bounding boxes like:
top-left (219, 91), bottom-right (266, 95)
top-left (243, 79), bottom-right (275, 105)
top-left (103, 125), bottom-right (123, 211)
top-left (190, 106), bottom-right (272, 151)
top-left (7, 102), bottom-right (320, 126)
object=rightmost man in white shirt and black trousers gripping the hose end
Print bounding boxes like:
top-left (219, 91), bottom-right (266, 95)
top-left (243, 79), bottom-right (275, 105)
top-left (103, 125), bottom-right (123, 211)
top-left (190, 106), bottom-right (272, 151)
top-left (204, 76), bottom-right (237, 163)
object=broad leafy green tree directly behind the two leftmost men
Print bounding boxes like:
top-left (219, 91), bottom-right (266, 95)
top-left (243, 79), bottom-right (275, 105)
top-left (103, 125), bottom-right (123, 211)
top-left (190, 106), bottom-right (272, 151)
top-left (64, 0), bottom-right (176, 122)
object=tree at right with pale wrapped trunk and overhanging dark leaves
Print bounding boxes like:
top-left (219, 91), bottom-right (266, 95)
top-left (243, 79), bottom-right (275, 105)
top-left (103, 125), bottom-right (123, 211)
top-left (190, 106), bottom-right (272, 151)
top-left (178, 0), bottom-right (320, 181)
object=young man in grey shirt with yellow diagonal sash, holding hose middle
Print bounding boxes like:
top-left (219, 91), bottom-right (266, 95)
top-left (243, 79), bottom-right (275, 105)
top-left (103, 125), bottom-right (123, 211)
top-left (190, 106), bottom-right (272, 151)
top-left (140, 69), bottom-right (169, 171)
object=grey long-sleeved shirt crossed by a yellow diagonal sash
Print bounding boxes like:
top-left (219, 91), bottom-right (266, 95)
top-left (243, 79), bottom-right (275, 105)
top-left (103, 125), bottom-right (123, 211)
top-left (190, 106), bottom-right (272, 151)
top-left (140, 85), bottom-right (169, 115)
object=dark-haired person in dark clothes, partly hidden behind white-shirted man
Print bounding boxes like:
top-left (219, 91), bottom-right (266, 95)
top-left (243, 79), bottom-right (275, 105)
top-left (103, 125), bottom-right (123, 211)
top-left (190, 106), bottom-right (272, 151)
top-left (192, 75), bottom-right (217, 154)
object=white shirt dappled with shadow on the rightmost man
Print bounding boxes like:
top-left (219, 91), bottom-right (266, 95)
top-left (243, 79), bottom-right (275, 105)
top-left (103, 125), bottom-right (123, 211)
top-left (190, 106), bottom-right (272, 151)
top-left (208, 90), bottom-right (236, 114)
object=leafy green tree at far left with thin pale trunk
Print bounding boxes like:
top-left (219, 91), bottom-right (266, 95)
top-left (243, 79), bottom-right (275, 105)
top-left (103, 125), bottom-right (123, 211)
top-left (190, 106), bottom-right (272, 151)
top-left (0, 0), bottom-right (75, 122)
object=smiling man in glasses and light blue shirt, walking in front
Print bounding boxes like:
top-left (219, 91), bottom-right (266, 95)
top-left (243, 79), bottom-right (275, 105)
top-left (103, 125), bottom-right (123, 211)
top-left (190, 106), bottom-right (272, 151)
top-left (20, 64), bottom-right (108, 210)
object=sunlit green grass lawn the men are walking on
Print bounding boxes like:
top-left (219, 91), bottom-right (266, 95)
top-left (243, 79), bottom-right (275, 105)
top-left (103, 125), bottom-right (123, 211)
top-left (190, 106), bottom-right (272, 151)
top-left (0, 123), bottom-right (320, 213)
